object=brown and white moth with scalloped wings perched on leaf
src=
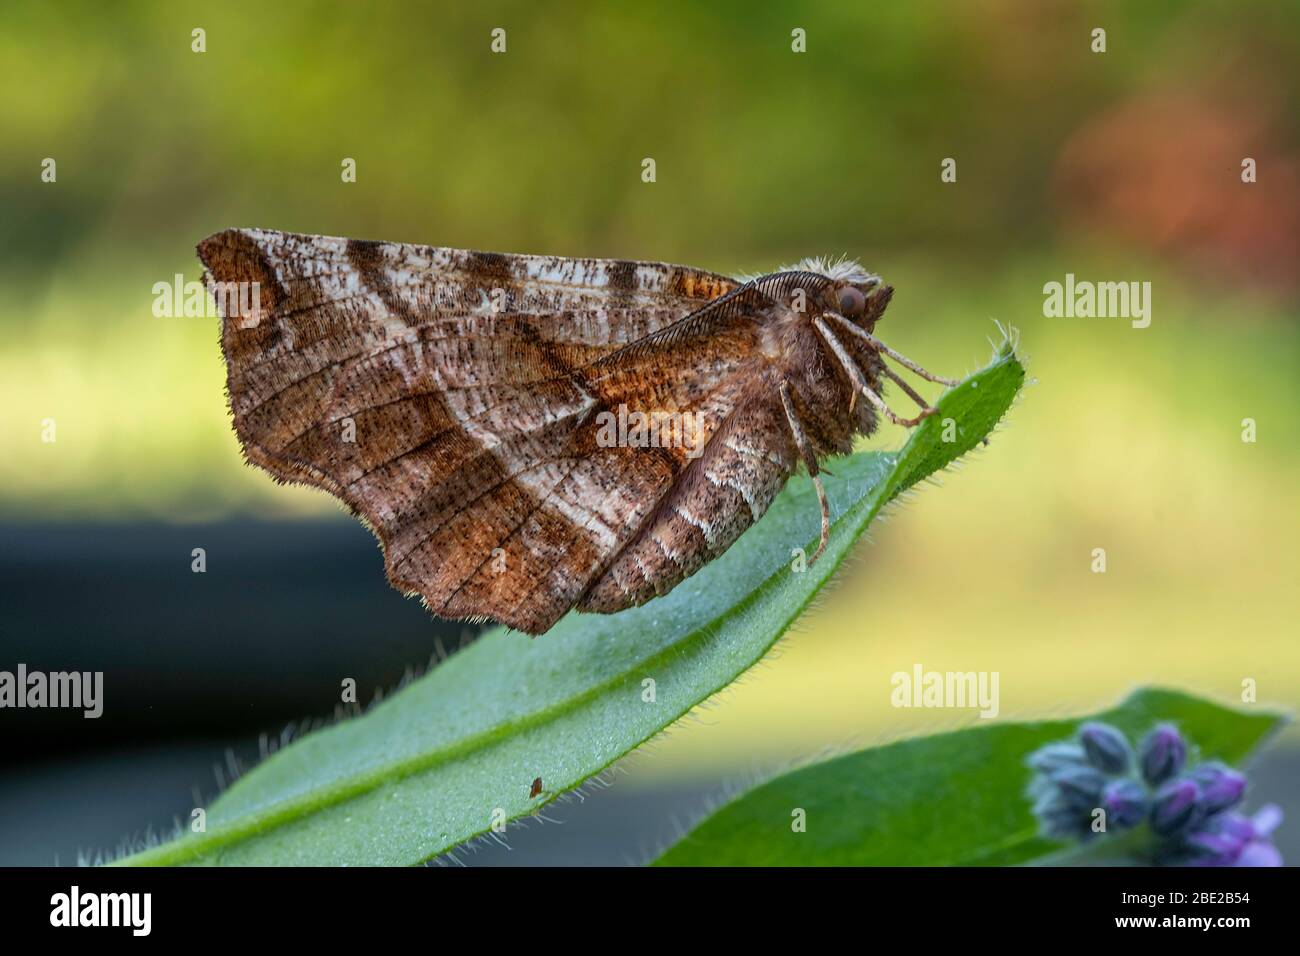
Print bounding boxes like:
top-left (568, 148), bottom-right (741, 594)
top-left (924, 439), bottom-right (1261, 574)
top-left (198, 229), bottom-right (956, 635)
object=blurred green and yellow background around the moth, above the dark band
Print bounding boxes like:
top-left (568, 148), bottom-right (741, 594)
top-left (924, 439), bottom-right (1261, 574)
top-left (0, 0), bottom-right (1300, 868)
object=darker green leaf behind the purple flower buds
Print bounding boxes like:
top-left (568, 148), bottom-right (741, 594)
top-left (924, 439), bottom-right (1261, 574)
top-left (655, 688), bottom-right (1283, 866)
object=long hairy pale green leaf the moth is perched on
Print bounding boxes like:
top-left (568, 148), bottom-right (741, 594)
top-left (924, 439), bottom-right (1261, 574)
top-left (111, 345), bottom-right (1024, 865)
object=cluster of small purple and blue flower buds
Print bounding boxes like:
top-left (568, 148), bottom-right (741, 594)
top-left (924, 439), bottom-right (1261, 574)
top-left (1027, 723), bottom-right (1282, 866)
